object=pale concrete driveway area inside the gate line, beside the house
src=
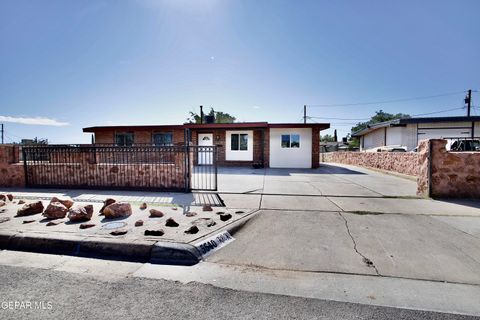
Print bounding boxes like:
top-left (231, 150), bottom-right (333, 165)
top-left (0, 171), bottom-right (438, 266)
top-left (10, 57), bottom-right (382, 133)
top-left (218, 163), bottom-right (416, 197)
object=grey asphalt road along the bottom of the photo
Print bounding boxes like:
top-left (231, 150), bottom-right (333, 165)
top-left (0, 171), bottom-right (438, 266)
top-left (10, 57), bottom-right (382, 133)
top-left (0, 266), bottom-right (474, 319)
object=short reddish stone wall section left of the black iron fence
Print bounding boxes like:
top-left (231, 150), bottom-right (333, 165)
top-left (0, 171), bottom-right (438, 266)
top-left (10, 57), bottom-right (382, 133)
top-left (0, 144), bottom-right (25, 187)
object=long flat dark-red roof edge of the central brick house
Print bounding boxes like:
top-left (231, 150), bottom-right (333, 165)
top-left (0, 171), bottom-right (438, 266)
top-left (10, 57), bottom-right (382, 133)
top-left (83, 122), bottom-right (330, 132)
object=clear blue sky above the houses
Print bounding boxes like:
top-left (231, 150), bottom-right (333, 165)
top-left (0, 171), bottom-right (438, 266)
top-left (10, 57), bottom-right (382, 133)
top-left (0, 0), bottom-right (480, 143)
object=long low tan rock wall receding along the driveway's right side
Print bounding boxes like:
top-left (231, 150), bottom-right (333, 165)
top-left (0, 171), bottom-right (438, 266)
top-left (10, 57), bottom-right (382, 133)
top-left (321, 152), bottom-right (419, 176)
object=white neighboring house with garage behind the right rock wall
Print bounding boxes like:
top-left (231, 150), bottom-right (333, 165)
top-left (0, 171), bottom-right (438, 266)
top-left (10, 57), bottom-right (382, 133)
top-left (352, 116), bottom-right (480, 151)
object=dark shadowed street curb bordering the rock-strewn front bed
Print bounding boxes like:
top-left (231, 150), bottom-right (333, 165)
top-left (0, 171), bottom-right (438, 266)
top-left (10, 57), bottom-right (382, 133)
top-left (0, 232), bottom-right (201, 266)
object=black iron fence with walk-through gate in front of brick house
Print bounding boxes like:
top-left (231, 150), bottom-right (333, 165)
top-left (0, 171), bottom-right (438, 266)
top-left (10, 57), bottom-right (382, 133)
top-left (22, 145), bottom-right (217, 192)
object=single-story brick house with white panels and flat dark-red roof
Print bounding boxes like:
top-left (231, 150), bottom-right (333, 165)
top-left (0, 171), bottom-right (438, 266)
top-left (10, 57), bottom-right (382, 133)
top-left (83, 122), bottom-right (330, 168)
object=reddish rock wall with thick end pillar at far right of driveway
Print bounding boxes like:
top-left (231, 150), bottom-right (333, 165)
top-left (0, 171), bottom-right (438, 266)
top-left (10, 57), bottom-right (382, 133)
top-left (417, 139), bottom-right (480, 199)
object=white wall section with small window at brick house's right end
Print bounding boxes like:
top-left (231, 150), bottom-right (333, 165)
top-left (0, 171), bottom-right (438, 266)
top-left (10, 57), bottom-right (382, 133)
top-left (270, 128), bottom-right (312, 168)
